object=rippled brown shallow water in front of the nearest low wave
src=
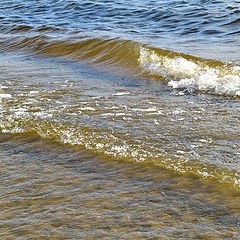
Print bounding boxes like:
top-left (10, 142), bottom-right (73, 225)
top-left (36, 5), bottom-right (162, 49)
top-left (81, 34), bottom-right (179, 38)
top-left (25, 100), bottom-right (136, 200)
top-left (0, 135), bottom-right (240, 239)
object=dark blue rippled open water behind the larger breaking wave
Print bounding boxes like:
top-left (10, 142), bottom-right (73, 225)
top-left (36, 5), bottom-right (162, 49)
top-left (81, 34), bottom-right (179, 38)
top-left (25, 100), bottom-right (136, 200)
top-left (0, 0), bottom-right (240, 60)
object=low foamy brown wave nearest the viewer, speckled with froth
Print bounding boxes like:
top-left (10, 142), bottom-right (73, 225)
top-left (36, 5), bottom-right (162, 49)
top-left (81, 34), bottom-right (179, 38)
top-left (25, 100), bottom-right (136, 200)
top-left (0, 109), bottom-right (240, 190)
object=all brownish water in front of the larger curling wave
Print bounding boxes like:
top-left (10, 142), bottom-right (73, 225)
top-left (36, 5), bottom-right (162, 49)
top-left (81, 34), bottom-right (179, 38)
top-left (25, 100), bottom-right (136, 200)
top-left (0, 52), bottom-right (240, 239)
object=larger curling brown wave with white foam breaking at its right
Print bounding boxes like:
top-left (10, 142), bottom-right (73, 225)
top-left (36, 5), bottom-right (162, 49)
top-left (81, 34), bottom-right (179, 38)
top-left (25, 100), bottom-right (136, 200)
top-left (0, 33), bottom-right (240, 97)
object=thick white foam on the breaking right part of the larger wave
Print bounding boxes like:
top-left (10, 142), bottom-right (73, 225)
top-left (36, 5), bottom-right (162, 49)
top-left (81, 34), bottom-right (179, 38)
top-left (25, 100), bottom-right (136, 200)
top-left (138, 48), bottom-right (240, 96)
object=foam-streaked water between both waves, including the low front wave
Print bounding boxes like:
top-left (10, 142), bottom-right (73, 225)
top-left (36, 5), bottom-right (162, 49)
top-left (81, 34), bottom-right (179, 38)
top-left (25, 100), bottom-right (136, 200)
top-left (0, 55), bottom-right (239, 189)
